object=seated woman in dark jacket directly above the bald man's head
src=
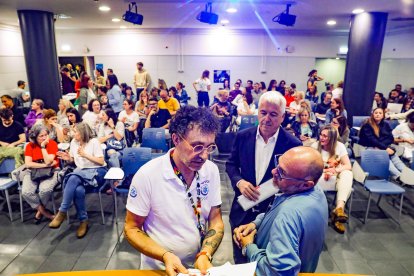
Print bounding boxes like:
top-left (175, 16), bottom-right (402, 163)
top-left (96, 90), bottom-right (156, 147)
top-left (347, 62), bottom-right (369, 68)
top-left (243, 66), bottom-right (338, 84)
top-left (291, 107), bottom-right (319, 146)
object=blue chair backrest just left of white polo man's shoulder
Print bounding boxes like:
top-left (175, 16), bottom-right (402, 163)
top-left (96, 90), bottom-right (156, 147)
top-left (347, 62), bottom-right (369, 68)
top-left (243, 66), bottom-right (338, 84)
top-left (122, 147), bottom-right (151, 176)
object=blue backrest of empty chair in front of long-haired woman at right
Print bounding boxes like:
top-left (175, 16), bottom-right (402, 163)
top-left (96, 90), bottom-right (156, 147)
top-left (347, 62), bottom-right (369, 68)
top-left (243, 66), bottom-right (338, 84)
top-left (361, 149), bottom-right (390, 179)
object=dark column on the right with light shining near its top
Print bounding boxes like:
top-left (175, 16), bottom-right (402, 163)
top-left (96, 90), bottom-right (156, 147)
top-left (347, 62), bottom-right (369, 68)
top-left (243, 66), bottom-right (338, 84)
top-left (343, 12), bottom-right (388, 122)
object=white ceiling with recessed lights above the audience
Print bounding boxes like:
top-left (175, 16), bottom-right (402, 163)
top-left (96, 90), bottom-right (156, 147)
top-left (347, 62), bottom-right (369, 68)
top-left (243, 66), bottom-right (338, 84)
top-left (0, 0), bottom-right (414, 32)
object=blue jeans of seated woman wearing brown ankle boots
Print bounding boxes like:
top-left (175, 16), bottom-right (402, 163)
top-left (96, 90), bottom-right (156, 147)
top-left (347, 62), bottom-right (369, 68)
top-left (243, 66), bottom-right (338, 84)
top-left (59, 167), bottom-right (107, 221)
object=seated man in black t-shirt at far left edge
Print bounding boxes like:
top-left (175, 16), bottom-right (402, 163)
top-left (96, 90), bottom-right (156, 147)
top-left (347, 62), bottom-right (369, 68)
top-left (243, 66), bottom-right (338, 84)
top-left (0, 108), bottom-right (26, 168)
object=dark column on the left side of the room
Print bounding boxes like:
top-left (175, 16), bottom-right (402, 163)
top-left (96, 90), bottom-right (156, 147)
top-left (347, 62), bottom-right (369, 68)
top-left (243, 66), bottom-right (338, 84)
top-left (17, 10), bottom-right (62, 110)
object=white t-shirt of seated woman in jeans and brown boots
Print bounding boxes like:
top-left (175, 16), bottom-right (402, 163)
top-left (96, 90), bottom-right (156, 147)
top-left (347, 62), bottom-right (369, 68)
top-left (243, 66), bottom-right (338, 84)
top-left (69, 138), bottom-right (103, 169)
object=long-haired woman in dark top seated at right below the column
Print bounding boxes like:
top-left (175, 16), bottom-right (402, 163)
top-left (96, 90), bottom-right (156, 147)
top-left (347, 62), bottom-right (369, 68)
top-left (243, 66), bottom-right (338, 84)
top-left (359, 108), bottom-right (405, 181)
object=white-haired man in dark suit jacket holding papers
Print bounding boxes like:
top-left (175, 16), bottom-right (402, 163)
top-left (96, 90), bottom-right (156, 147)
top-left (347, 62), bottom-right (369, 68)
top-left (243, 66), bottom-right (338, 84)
top-left (226, 92), bottom-right (302, 263)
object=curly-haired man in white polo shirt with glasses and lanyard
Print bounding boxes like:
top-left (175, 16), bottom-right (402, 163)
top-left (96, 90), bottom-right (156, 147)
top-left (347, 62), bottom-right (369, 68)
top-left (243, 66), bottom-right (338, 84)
top-left (125, 106), bottom-right (224, 275)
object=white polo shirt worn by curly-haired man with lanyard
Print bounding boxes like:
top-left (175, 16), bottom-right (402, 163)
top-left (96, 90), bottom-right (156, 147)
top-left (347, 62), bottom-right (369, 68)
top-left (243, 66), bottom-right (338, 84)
top-left (126, 149), bottom-right (221, 269)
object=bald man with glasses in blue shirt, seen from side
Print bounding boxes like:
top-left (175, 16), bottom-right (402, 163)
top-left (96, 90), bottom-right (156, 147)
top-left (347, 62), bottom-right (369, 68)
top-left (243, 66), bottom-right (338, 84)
top-left (233, 147), bottom-right (328, 276)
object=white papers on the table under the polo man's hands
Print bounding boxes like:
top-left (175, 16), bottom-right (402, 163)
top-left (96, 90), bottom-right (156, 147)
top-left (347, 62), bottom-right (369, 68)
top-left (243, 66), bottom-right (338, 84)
top-left (178, 262), bottom-right (257, 276)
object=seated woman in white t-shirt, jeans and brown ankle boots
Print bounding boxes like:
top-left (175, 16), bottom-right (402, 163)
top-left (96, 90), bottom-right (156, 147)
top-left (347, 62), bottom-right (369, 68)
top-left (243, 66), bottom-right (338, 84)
top-left (49, 123), bottom-right (107, 238)
